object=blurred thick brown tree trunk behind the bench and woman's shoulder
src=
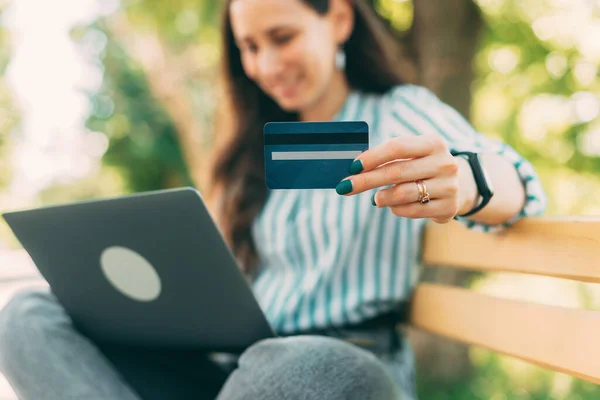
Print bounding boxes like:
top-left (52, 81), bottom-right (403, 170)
top-left (410, 0), bottom-right (482, 383)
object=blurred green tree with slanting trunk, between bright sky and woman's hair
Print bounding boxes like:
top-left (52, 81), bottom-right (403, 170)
top-left (83, 0), bottom-right (224, 189)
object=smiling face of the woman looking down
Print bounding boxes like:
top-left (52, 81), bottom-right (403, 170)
top-left (230, 0), bottom-right (352, 112)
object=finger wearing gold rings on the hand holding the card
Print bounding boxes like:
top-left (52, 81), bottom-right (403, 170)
top-left (373, 178), bottom-right (458, 207)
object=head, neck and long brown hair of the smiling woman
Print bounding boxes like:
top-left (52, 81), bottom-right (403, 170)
top-left (210, 0), bottom-right (404, 269)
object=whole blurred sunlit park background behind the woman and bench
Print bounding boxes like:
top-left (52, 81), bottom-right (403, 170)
top-left (0, 0), bottom-right (600, 400)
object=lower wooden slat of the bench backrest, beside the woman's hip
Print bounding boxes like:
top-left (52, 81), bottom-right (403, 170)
top-left (411, 283), bottom-right (600, 384)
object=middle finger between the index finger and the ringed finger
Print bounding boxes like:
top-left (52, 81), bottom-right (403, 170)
top-left (340, 155), bottom-right (458, 194)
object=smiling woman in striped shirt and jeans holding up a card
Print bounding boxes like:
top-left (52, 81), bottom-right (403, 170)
top-left (0, 0), bottom-right (546, 400)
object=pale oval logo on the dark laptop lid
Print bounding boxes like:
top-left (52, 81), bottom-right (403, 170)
top-left (100, 246), bottom-right (161, 301)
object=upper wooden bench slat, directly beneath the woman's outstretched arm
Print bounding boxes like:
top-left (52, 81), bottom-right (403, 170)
top-left (423, 217), bottom-right (600, 282)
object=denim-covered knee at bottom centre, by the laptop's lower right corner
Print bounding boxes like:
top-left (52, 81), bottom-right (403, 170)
top-left (219, 336), bottom-right (398, 400)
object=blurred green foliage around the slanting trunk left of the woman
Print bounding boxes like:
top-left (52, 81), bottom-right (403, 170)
top-left (82, 0), bottom-right (225, 191)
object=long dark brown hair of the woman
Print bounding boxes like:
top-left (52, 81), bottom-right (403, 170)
top-left (208, 0), bottom-right (412, 272)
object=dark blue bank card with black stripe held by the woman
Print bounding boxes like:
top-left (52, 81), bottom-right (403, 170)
top-left (263, 121), bottom-right (369, 189)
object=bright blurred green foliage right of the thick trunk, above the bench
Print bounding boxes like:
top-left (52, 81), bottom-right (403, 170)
top-left (472, 0), bottom-right (600, 215)
